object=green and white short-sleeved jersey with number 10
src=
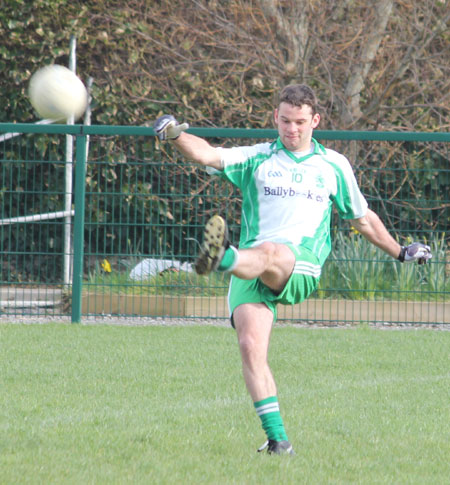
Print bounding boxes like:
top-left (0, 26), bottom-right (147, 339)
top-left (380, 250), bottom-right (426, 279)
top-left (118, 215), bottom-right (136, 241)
top-left (214, 139), bottom-right (367, 265)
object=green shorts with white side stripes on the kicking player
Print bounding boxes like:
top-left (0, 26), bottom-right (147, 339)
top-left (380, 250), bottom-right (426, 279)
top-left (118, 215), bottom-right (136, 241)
top-left (228, 244), bottom-right (321, 326)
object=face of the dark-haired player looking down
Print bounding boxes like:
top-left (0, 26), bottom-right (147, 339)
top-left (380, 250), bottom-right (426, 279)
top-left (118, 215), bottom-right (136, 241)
top-left (274, 103), bottom-right (320, 152)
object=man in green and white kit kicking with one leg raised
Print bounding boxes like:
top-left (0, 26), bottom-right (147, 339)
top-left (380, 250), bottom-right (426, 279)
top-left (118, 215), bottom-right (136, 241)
top-left (154, 84), bottom-right (431, 454)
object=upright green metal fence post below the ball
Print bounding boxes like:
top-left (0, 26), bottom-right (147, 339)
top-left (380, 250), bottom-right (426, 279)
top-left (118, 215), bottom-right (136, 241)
top-left (72, 135), bottom-right (87, 323)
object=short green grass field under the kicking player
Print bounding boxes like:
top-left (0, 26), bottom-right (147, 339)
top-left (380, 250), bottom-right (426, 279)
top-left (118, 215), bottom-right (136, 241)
top-left (0, 324), bottom-right (450, 485)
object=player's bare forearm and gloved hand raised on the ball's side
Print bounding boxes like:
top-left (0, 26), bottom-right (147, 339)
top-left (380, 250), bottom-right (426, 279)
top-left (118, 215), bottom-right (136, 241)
top-left (153, 115), bottom-right (222, 170)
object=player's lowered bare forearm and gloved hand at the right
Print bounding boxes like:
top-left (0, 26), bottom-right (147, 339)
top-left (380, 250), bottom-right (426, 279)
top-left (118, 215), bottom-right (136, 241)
top-left (351, 209), bottom-right (432, 264)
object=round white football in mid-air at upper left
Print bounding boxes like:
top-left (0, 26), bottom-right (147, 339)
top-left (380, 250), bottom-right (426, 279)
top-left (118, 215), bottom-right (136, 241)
top-left (28, 64), bottom-right (88, 121)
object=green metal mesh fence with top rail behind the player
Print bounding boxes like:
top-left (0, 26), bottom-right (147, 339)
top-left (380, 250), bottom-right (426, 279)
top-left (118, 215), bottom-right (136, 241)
top-left (0, 124), bottom-right (450, 324)
